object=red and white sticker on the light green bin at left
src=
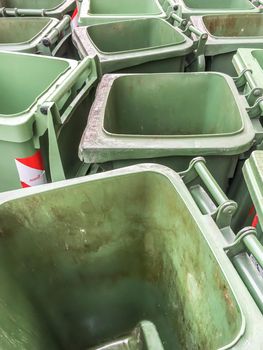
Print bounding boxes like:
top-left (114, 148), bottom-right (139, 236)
top-left (15, 151), bottom-right (47, 188)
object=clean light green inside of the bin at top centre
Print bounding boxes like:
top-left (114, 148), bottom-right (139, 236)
top-left (89, 0), bottom-right (161, 15)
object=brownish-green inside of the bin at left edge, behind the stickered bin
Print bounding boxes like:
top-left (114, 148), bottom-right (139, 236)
top-left (0, 17), bottom-right (51, 45)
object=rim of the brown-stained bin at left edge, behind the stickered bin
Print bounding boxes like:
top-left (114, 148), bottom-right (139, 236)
top-left (0, 17), bottom-right (59, 47)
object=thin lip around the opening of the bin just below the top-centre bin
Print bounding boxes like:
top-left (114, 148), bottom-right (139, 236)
top-left (85, 18), bottom-right (193, 56)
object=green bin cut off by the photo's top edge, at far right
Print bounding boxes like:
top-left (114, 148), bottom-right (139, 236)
top-left (172, 0), bottom-right (260, 19)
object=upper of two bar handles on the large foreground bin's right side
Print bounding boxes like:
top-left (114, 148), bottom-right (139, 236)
top-left (179, 157), bottom-right (237, 228)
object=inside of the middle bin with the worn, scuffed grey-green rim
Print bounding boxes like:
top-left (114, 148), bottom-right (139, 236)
top-left (104, 73), bottom-right (243, 136)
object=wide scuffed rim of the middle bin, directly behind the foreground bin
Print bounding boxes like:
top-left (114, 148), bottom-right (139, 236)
top-left (79, 72), bottom-right (255, 163)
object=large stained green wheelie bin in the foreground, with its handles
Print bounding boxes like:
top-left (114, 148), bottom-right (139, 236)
top-left (0, 159), bottom-right (263, 350)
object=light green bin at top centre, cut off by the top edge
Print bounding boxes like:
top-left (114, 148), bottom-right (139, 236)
top-left (78, 0), bottom-right (171, 26)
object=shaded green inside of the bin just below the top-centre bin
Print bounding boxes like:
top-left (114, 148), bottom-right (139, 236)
top-left (87, 19), bottom-right (185, 53)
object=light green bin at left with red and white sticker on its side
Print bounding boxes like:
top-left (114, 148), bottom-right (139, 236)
top-left (0, 52), bottom-right (97, 191)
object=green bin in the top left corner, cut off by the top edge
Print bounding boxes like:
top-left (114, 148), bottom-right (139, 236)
top-left (0, 0), bottom-right (76, 18)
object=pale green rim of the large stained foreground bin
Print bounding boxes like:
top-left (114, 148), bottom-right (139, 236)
top-left (0, 163), bottom-right (263, 350)
